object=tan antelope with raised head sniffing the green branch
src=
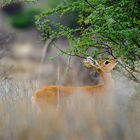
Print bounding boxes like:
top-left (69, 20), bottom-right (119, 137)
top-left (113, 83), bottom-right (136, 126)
top-left (33, 57), bottom-right (116, 104)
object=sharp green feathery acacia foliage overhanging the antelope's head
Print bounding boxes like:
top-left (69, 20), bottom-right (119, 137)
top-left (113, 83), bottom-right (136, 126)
top-left (36, 0), bottom-right (140, 68)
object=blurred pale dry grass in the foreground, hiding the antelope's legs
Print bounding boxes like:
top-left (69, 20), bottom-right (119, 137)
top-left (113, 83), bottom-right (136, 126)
top-left (0, 77), bottom-right (140, 140)
